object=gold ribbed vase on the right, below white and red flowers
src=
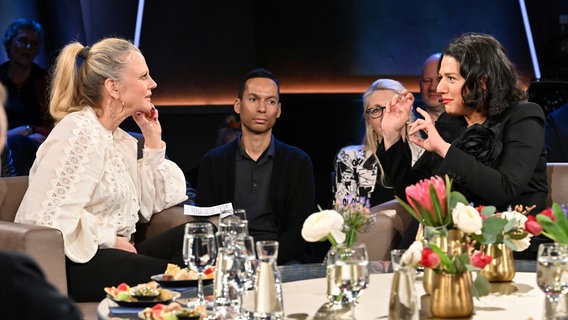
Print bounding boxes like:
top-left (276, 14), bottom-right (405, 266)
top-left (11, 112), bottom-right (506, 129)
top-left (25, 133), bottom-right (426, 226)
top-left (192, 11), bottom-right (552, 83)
top-left (481, 243), bottom-right (515, 282)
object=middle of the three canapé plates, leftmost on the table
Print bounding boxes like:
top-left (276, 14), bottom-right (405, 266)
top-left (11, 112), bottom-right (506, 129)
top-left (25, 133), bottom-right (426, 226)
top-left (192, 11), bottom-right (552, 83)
top-left (104, 281), bottom-right (181, 308)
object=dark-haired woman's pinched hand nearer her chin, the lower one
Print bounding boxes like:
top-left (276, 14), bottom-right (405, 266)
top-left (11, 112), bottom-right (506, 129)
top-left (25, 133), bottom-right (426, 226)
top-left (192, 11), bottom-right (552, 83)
top-left (408, 108), bottom-right (450, 158)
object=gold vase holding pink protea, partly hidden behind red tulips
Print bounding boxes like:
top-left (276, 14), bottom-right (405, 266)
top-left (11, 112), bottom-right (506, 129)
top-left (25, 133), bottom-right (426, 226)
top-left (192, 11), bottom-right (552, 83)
top-left (422, 227), bottom-right (467, 294)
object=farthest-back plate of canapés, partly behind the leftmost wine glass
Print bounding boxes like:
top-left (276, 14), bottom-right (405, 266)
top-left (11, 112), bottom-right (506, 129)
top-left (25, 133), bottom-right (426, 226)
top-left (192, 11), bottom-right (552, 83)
top-left (151, 263), bottom-right (215, 288)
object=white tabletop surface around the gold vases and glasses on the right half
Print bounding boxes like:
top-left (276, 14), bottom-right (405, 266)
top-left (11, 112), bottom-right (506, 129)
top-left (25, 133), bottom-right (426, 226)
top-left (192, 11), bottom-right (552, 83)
top-left (282, 272), bottom-right (545, 320)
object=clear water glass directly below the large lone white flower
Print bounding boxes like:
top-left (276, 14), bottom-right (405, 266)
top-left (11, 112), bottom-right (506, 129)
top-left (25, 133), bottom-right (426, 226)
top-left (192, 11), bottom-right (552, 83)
top-left (328, 244), bottom-right (369, 304)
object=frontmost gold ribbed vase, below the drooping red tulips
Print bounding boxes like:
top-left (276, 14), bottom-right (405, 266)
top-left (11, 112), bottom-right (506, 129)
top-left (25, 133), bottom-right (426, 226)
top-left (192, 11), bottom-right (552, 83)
top-left (430, 272), bottom-right (473, 318)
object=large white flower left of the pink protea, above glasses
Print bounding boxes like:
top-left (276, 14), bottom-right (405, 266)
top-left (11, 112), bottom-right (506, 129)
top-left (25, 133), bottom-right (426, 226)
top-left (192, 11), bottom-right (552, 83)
top-left (302, 210), bottom-right (345, 243)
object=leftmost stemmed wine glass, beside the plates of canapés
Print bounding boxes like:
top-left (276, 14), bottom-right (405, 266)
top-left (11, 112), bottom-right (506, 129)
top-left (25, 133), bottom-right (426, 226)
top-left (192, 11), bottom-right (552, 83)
top-left (182, 222), bottom-right (217, 307)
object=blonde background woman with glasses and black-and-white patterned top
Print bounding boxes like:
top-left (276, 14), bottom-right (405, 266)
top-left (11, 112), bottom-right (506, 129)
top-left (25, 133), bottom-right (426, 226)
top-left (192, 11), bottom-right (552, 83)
top-left (335, 79), bottom-right (414, 207)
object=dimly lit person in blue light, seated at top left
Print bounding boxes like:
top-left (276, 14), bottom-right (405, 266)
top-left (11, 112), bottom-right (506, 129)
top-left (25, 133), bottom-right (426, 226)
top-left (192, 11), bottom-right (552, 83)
top-left (0, 19), bottom-right (53, 175)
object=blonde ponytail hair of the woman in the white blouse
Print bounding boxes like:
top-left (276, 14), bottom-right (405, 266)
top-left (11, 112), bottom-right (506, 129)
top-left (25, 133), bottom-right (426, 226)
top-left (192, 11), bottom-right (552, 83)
top-left (49, 38), bottom-right (140, 122)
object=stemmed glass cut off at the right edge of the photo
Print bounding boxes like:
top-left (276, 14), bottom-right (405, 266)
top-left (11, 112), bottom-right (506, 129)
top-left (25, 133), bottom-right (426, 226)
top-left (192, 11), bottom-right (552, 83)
top-left (536, 243), bottom-right (568, 319)
